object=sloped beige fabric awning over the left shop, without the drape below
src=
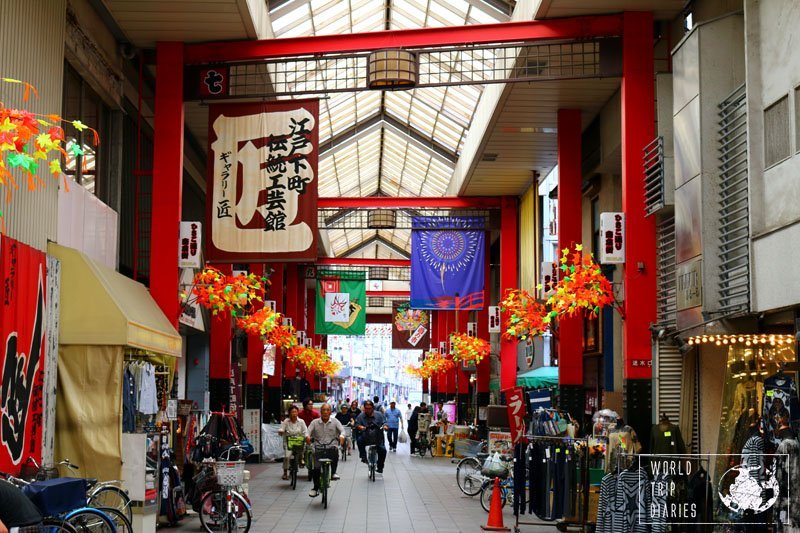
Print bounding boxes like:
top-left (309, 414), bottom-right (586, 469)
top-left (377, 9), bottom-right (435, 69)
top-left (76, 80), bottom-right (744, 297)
top-left (47, 243), bottom-right (181, 357)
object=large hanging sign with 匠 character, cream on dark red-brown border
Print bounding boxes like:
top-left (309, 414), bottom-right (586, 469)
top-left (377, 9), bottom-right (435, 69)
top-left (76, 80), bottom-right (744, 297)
top-left (206, 100), bottom-right (319, 263)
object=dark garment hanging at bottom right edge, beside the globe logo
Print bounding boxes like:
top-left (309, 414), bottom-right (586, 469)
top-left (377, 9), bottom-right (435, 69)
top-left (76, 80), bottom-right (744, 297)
top-left (773, 439), bottom-right (800, 533)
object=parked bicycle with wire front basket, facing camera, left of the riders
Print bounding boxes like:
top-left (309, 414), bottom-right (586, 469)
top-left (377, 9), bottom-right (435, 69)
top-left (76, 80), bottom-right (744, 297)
top-left (200, 445), bottom-right (252, 533)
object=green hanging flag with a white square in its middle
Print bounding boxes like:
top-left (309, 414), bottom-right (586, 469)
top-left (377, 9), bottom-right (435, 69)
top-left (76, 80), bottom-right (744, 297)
top-left (314, 271), bottom-right (367, 335)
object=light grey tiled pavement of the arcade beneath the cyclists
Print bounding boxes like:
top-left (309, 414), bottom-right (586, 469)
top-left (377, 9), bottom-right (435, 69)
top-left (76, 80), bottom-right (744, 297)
top-left (170, 444), bottom-right (557, 533)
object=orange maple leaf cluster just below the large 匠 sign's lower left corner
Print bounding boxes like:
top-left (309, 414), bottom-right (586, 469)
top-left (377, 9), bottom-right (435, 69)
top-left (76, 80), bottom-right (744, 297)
top-left (192, 266), bottom-right (269, 317)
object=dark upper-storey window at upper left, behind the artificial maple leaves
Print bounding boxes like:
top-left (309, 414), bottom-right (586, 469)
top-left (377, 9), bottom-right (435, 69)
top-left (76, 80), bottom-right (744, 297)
top-left (62, 63), bottom-right (110, 196)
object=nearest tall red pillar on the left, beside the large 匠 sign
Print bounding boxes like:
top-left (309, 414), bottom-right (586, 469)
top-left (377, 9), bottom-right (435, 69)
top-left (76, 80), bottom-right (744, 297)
top-left (150, 42), bottom-right (183, 328)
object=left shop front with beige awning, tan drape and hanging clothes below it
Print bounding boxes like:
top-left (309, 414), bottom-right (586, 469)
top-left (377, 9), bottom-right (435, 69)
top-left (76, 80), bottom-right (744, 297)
top-left (48, 244), bottom-right (181, 480)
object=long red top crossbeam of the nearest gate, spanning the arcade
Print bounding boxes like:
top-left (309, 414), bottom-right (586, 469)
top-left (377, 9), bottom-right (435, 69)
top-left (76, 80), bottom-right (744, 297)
top-left (185, 14), bottom-right (622, 64)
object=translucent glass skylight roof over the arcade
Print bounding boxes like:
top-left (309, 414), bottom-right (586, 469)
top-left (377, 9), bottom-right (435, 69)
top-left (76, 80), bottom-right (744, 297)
top-left (270, 0), bottom-right (510, 256)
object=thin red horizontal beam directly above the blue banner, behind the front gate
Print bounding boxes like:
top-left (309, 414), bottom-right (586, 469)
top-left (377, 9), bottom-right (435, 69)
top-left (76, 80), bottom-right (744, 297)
top-left (317, 196), bottom-right (503, 209)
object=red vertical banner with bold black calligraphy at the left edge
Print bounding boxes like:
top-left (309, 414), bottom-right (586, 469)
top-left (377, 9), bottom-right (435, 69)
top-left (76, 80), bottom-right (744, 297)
top-left (0, 237), bottom-right (47, 473)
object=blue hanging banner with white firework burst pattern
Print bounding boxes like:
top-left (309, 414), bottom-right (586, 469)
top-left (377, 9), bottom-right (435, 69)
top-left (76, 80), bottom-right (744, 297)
top-left (411, 217), bottom-right (486, 310)
